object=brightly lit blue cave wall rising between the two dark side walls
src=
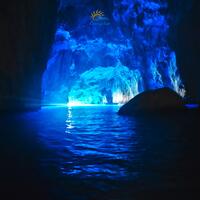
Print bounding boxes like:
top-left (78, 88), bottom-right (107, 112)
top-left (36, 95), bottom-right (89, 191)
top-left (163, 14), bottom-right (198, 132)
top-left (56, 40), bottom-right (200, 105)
top-left (42, 0), bottom-right (184, 104)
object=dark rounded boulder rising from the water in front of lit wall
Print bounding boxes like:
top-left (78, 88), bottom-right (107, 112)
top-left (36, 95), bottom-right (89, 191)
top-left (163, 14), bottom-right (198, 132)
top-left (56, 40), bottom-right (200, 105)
top-left (119, 88), bottom-right (184, 115)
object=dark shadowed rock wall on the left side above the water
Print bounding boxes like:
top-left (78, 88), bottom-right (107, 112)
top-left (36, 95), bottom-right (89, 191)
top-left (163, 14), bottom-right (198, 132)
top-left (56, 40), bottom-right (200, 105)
top-left (0, 0), bottom-right (57, 110)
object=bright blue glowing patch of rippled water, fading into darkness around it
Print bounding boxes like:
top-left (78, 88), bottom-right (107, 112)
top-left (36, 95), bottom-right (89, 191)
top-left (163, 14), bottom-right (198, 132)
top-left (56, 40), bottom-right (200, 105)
top-left (25, 106), bottom-right (177, 180)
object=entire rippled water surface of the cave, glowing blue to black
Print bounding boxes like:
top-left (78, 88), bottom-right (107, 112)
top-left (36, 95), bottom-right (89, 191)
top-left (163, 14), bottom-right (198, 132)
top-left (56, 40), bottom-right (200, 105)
top-left (0, 106), bottom-right (200, 200)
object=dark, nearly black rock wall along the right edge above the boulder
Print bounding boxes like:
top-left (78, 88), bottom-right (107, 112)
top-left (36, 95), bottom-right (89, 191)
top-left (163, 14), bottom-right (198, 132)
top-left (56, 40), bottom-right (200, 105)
top-left (169, 0), bottom-right (200, 102)
